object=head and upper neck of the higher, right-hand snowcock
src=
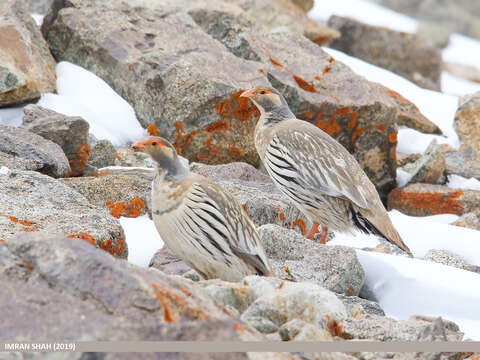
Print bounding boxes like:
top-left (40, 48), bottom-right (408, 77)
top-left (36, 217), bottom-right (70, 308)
top-left (240, 87), bottom-right (295, 124)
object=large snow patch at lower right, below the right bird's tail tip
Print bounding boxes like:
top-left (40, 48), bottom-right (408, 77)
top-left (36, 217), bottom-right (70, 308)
top-left (357, 250), bottom-right (480, 340)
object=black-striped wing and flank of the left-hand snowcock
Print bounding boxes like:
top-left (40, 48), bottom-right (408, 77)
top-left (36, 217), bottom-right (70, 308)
top-left (180, 183), bottom-right (270, 275)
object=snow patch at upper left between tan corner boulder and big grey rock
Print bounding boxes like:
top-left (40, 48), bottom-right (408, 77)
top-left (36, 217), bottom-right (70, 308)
top-left (38, 61), bottom-right (147, 146)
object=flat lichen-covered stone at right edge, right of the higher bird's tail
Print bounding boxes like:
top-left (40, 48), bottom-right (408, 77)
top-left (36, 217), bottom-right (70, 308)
top-left (388, 184), bottom-right (480, 216)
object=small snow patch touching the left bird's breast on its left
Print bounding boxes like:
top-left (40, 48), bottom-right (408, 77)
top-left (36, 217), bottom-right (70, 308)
top-left (120, 215), bottom-right (163, 267)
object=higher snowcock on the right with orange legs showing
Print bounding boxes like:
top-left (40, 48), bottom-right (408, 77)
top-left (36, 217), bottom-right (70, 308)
top-left (240, 87), bottom-right (412, 255)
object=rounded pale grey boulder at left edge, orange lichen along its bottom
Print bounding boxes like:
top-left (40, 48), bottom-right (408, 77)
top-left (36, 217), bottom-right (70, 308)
top-left (0, 170), bottom-right (128, 258)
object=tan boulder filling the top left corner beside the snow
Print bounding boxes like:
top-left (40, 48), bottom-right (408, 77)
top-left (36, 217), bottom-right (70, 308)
top-left (0, 0), bottom-right (56, 106)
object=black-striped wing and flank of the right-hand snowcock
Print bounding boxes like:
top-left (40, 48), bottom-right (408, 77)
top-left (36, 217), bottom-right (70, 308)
top-left (264, 120), bottom-right (368, 209)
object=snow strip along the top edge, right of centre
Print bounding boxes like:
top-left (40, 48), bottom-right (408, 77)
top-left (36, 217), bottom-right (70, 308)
top-left (308, 0), bottom-right (418, 33)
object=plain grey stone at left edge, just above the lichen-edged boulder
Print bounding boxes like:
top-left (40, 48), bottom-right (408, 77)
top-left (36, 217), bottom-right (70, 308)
top-left (0, 124), bottom-right (70, 178)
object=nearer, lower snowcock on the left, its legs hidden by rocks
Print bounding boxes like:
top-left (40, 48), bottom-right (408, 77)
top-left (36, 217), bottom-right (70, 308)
top-left (132, 137), bottom-right (271, 281)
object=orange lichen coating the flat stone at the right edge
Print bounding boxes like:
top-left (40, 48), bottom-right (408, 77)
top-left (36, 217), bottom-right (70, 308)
top-left (388, 189), bottom-right (463, 216)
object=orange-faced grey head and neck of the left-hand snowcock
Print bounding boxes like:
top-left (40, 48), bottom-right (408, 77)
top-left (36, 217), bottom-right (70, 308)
top-left (132, 136), bottom-right (188, 180)
